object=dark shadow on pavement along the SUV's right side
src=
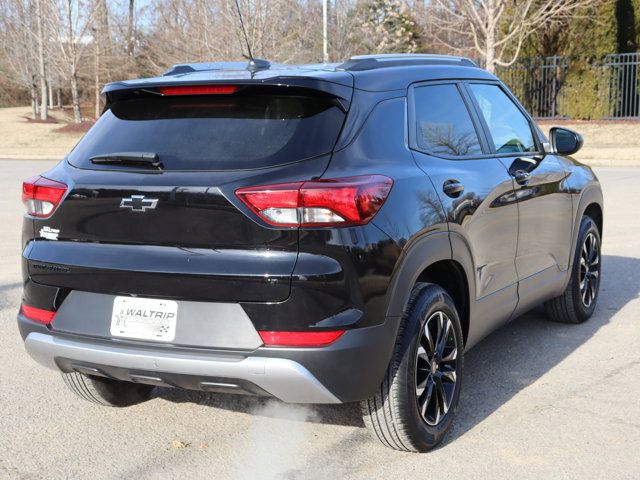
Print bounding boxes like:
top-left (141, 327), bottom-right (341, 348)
top-left (443, 255), bottom-right (640, 446)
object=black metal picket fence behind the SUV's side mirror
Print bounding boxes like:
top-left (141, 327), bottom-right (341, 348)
top-left (496, 53), bottom-right (640, 119)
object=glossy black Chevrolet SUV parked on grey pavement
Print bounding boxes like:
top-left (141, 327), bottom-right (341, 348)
top-left (18, 55), bottom-right (603, 451)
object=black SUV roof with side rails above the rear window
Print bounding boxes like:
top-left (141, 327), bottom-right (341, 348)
top-left (103, 54), bottom-right (496, 95)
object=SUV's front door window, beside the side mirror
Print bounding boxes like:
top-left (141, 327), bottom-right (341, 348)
top-left (469, 83), bottom-right (538, 153)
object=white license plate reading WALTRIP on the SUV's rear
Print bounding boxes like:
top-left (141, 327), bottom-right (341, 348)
top-left (111, 297), bottom-right (178, 342)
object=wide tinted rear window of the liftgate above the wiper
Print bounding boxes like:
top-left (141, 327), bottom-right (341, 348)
top-left (69, 87), bottom-right (345, 170)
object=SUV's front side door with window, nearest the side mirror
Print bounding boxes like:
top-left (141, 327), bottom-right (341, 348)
top-left (468, 82), bottom-right (572, 310)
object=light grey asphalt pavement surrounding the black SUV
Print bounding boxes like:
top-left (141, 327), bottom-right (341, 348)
top-left (0, 160), bottom-right (640, 480)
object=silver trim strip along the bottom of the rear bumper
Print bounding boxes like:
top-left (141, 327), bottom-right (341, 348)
top-left (25, 332), bottom-right (340, 403)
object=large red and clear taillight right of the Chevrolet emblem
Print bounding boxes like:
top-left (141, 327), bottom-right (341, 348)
top-left (236, 175), bottom-right (393, 227)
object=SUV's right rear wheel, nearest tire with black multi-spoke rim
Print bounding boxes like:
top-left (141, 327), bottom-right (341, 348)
top-left (361, 283), bottom-right (464, 452)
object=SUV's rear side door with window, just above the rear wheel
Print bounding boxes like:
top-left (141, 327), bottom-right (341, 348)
top-left (409, 82), bottom-right (518, 342)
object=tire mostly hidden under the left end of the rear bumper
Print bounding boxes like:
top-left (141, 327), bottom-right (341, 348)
top-left (62, 372), bottom-right (153, 407)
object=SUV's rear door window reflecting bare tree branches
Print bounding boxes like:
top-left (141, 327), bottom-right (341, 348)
top-left (414, 84), bottom-right (482, 157)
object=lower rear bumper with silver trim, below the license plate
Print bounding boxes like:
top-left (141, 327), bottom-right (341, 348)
top-left (18, 314), bottom-right (398, 403)
